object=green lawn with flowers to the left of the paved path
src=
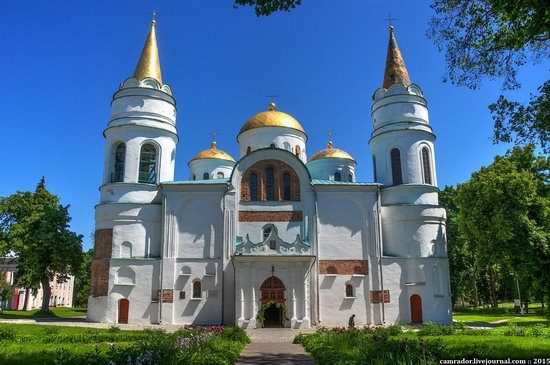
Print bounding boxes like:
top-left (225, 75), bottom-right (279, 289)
top-left (0, 323), bottom-right (249, 365)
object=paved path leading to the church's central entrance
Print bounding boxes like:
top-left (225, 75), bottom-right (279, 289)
top-left (237, 328), bottom-right (315, 365)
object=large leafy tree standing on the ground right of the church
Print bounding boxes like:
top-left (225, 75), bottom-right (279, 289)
top-left (458, 145), bottom-right (550, 305)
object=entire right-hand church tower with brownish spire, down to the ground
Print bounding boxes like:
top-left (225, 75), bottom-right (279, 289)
top-left (369, 26), bottom-right (451, 323)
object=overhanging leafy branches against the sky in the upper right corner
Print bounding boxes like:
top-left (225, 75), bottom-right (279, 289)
top-left (428, 0), bottom-right (550, 152)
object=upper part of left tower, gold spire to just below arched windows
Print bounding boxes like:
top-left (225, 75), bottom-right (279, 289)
top-left (101, 20), bottom-right (178, 202)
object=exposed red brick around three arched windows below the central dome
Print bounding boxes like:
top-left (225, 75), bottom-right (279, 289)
top-left (241, 160), bottom-right (300, 201)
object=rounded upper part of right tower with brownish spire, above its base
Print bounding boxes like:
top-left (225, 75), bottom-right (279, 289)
top-left (369, 27), bottom-right (446, 257)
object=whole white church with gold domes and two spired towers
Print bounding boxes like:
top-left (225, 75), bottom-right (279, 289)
top-left (88, 21), bottom-right (451, 328)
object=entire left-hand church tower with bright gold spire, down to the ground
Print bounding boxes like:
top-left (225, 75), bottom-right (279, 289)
top-left (88, 20), bottom-right (178, 323)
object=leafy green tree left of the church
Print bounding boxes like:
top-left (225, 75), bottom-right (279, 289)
top-left (0, 178), bottom-right (82, 312)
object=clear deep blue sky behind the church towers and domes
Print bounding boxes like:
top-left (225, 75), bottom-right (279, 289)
top-left (0, 0), bottom-right (547, 248)
